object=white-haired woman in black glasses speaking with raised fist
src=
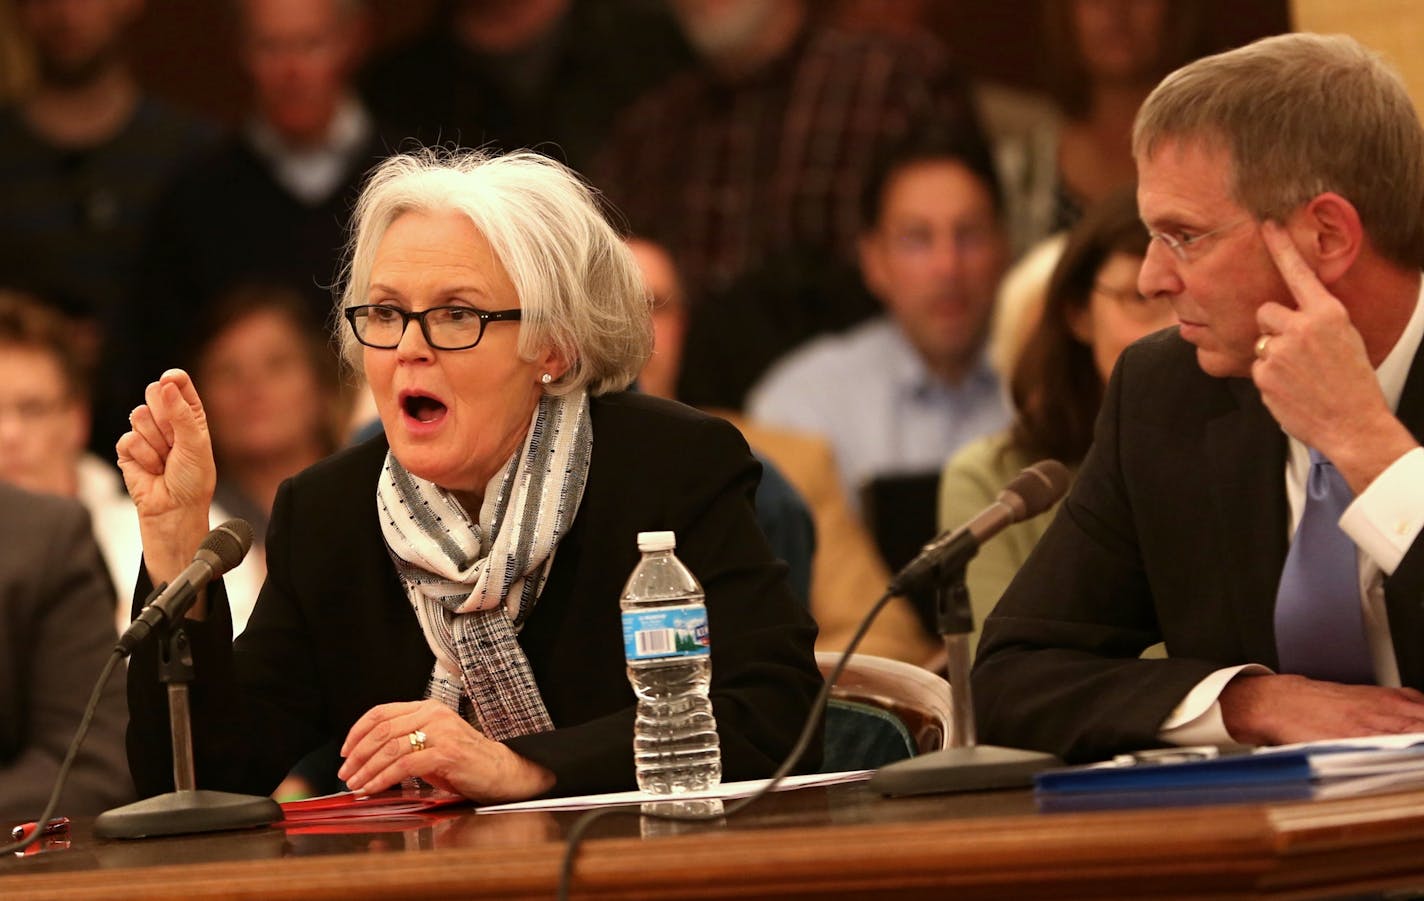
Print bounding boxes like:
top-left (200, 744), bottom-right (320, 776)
top-left (118, 152), bottom-right (820, 801)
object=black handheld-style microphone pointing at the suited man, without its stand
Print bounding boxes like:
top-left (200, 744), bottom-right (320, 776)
top-left (890, 460), bottom-right (1071, 595)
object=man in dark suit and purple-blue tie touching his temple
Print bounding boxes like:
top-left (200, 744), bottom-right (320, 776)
top-left (974, 34), bottom-right (1424, 760)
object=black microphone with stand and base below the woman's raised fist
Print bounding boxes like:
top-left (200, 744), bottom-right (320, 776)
top-left (94, 520), bottom-right (282, 838)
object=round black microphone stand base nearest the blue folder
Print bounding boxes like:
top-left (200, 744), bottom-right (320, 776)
top-left (867, 744), bottom-right (1064, 796)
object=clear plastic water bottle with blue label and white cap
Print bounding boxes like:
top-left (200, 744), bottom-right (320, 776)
top-left (622, 532), bottom-right (722, 794)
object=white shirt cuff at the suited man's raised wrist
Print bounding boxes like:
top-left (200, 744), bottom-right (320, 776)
top-left (1340, 447), bottom-right (1424, 576)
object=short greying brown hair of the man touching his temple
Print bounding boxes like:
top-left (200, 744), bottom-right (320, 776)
top-left (1132, 34), bottom-right (1424, 268)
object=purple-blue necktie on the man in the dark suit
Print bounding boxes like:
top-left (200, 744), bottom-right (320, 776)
top-left (1276, 450), bottom-right (1374, 685)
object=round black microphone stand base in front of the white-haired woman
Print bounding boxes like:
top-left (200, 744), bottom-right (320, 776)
top-left (94, 789), bottom-right (282, 838)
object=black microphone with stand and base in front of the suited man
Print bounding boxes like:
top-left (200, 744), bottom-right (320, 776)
top-left (869, 460), bottom-right (1072, 794)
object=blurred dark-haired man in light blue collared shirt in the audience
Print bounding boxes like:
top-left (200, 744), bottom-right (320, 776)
top-left (748, 131), bottom-right (1010, 512)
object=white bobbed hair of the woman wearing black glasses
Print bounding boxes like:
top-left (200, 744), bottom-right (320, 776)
top-left (335, 149), bottom-right (652, 394)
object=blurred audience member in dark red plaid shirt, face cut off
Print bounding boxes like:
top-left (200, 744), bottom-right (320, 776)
top-left (594, 0), bottom-right (980, 305)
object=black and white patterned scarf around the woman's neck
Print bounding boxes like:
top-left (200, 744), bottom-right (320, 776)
top-left (376, 391), bottom-right (594, 742)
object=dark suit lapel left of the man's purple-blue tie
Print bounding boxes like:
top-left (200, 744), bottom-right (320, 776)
top-left (1205, 379), bottom-right (1289, 668)
